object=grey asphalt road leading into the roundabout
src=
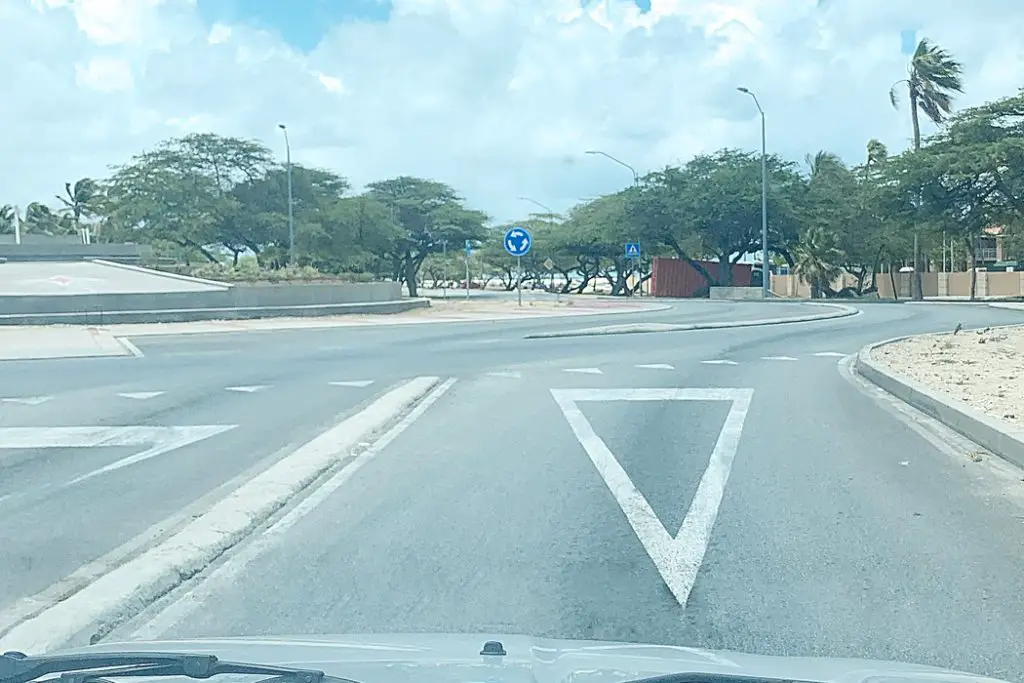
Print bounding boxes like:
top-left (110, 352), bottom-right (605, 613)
top-left (0, 303), bottom-right (1024, 681)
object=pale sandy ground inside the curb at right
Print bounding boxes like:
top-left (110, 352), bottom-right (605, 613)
top-left (871, 327), bottom-right (1024, 427)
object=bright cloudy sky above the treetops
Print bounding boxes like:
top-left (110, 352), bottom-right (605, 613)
top-left (0, 0), bottom-right (1024, 221)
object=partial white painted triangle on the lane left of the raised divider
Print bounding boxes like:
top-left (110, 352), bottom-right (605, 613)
top-left (0, 425), bottom-right (238, 486)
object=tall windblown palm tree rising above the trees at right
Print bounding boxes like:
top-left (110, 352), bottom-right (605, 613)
top-left (889, 38), bottom-right (964, 301)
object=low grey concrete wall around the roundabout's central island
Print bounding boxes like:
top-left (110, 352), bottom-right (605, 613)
top-left (0, 283), bottom-right (419, 325)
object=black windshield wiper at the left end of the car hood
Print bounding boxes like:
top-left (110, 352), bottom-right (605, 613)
top-left (0, 652), bottom-right (357, 683)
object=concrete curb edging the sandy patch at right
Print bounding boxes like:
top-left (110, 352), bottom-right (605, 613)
top-left (854, 333), bottom-right (1024, 468)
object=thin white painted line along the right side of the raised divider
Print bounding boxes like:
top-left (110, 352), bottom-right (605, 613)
top-left (118, 378), bottom-right (457, 640)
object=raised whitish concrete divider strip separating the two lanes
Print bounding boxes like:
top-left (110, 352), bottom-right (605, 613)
top-left (0, 377), bottom-right (440, 653)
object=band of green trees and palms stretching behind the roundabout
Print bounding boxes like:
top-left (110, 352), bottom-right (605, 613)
top-left (0, 40), bottom-right (1024, 296)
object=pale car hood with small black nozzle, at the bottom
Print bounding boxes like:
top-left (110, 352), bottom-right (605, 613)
top-left (51, 634), bottom-right (1005, 683)
